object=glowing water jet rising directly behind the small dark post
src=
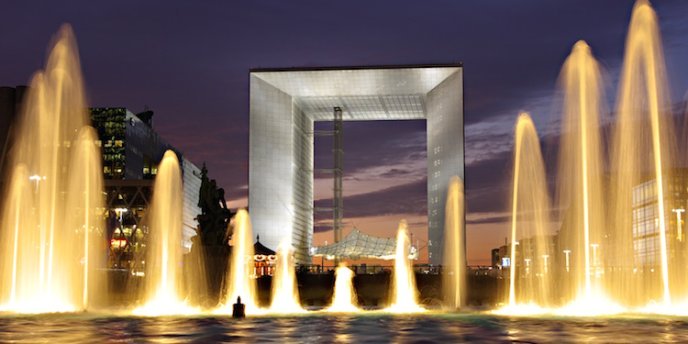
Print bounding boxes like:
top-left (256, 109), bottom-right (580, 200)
top-left (218, 209), bottom-right (259, 314)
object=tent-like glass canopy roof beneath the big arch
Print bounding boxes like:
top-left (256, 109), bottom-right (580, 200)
top-left (311, 228), bottom-right (418, 260)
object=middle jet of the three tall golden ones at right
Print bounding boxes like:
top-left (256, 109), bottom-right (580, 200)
top-left (556, 41), bottom-right (606, 311)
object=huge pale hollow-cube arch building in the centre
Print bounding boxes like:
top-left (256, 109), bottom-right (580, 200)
top-left (249, 64), bottom-right (464, 264)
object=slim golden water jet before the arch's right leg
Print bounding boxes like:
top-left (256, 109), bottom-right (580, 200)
top-left (442, 176), bottom-right (466, 309)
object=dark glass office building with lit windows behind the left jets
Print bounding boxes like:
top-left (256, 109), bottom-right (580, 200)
top-left (90, 107), bottom-right (201, 271)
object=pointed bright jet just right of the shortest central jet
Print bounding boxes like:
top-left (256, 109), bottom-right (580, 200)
top-left (387, 220), bottom-right (424, 313)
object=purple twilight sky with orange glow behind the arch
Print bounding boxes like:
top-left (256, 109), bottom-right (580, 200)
top-left (0, 0), bottom-right (688, 264)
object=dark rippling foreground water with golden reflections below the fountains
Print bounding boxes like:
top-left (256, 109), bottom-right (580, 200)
top-left (0, 314), bottom-right (688, 344)
